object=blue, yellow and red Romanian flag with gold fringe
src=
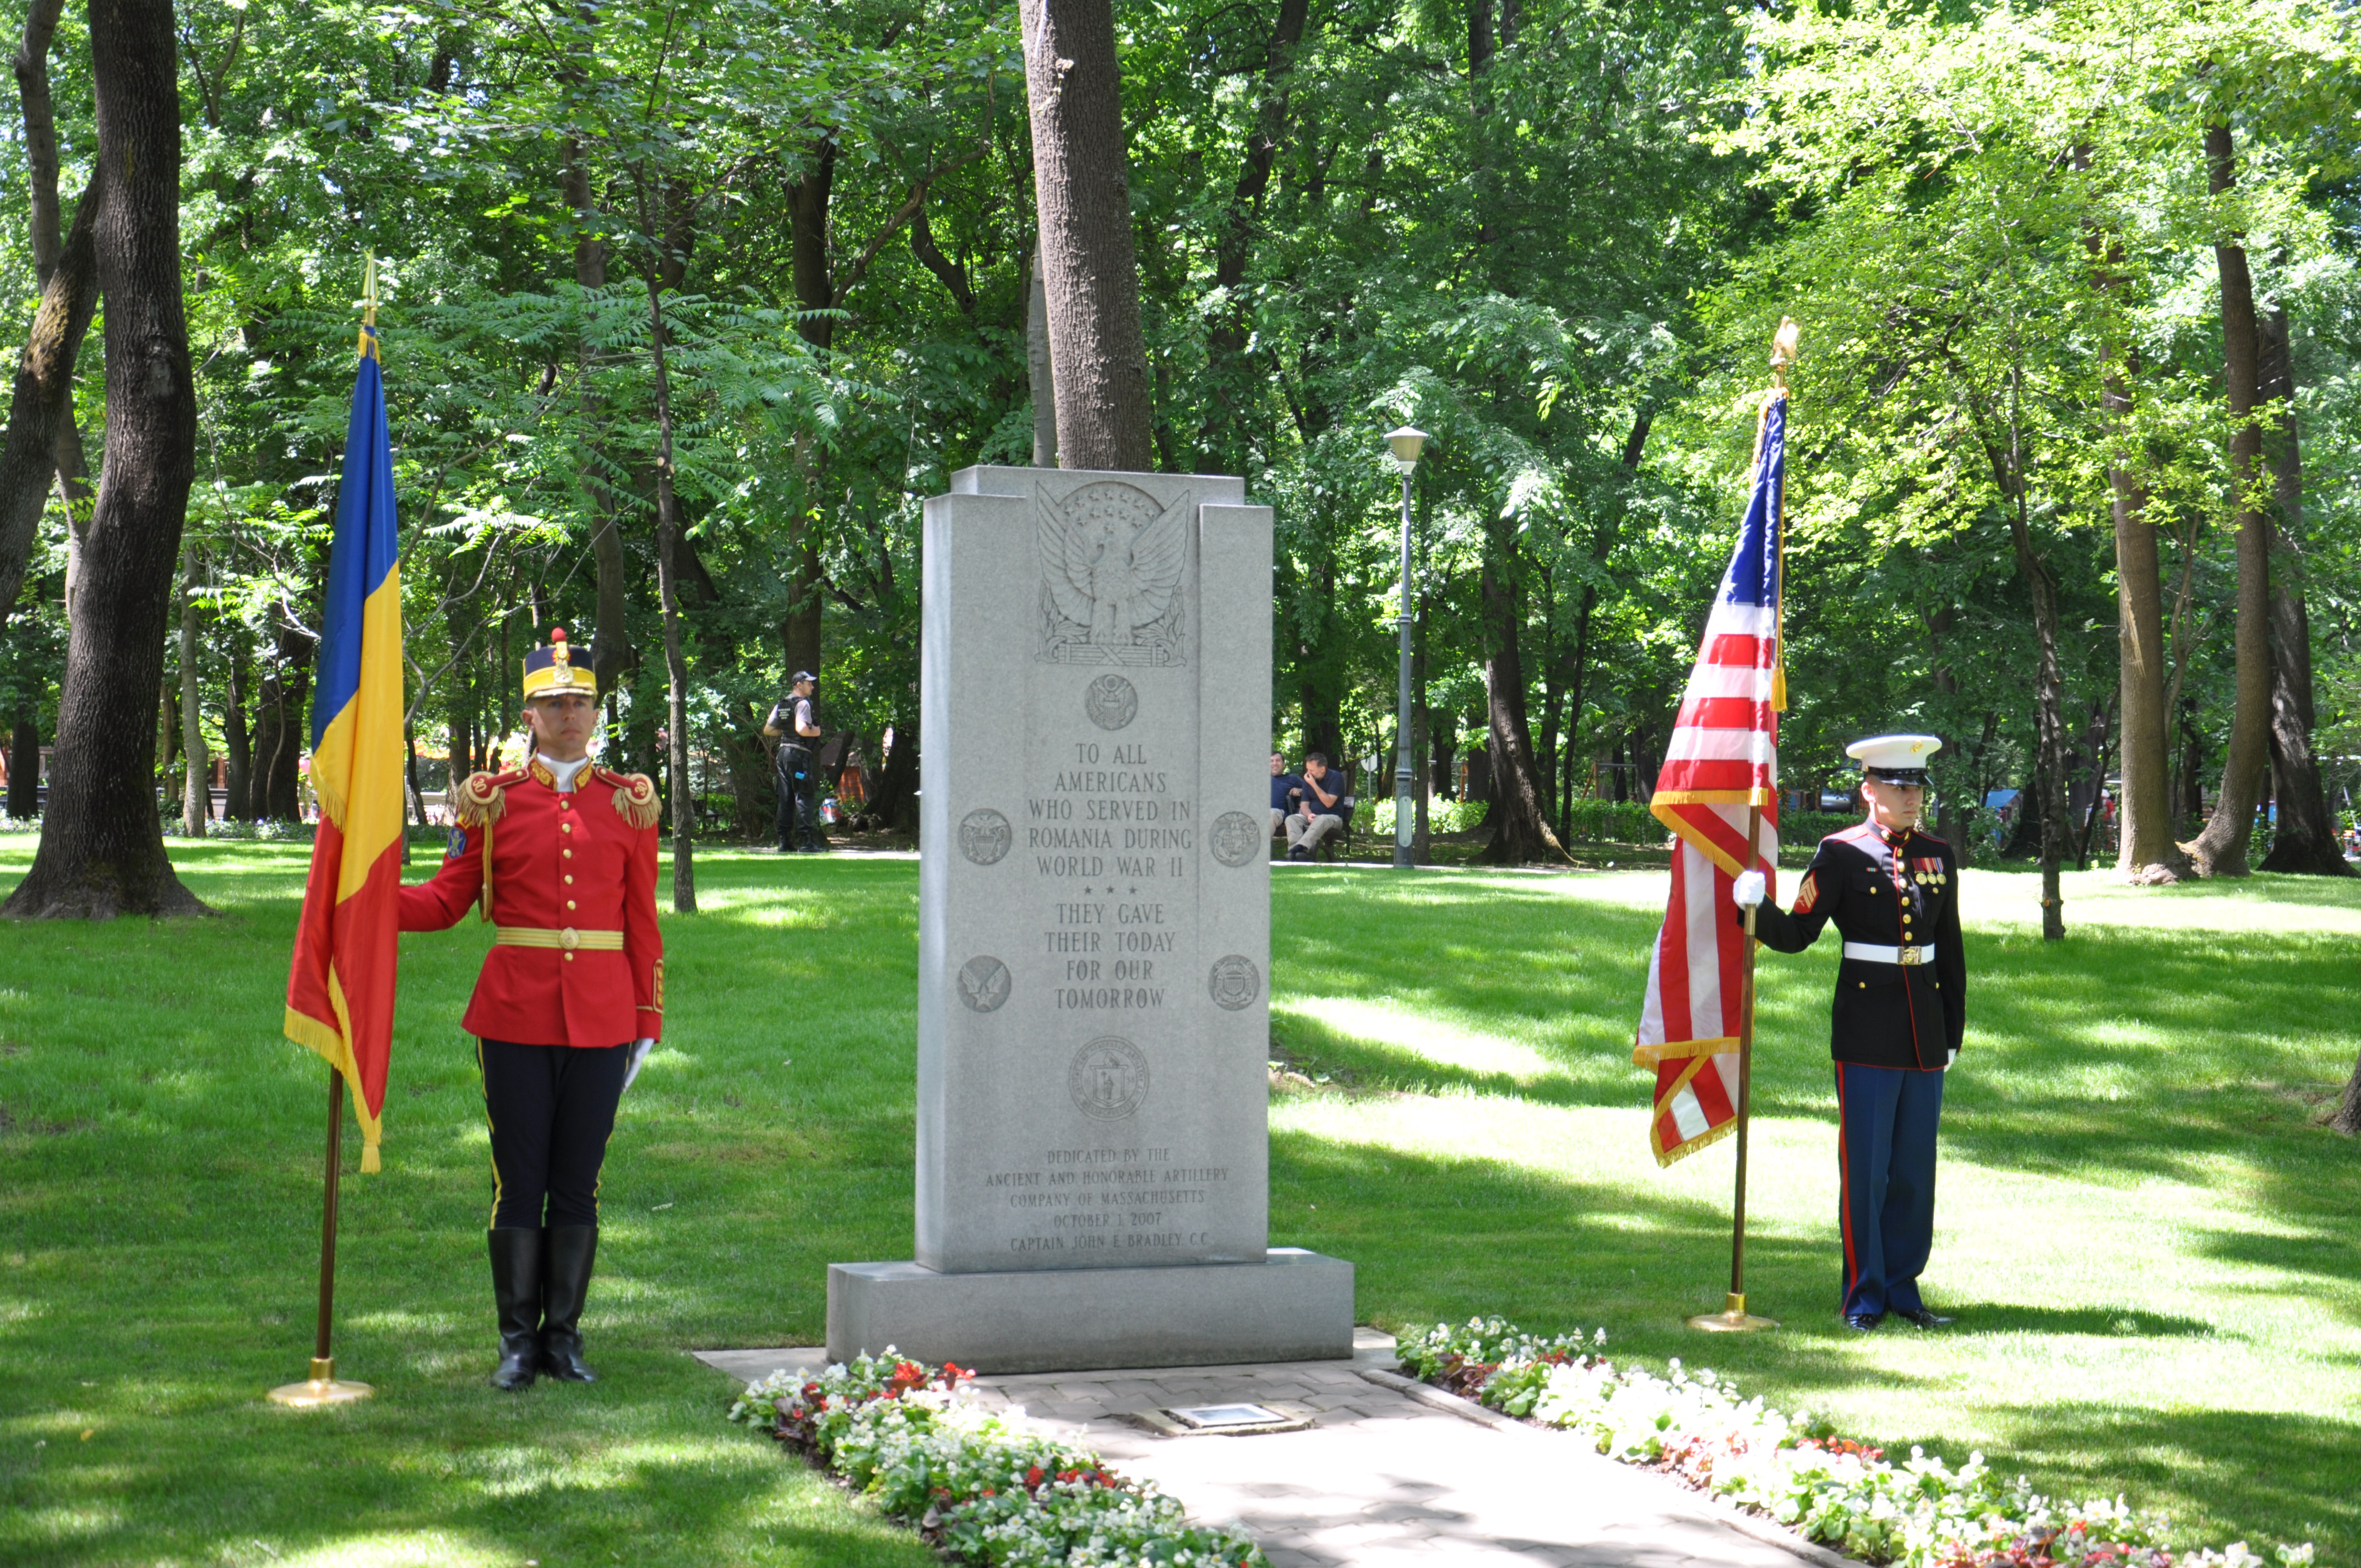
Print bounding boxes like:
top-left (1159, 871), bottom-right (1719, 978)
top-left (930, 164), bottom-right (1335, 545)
top-left (286, 326), bottom-right (401, 1171)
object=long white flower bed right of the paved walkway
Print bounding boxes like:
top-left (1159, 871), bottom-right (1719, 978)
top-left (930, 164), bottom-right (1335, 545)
top-left (1400, 1317), bottom-right (2311, 1568)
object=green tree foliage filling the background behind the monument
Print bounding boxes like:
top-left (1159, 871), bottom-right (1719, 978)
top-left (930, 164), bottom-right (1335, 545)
top-left (0, 0), bottom-right (2361, 883)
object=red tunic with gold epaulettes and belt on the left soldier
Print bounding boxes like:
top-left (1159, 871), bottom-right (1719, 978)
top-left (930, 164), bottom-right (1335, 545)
top-left (401, 763), bottom-right (663, 1046)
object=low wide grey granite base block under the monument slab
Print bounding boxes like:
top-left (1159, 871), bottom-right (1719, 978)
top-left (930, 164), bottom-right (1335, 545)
top-left (829, 1247), bottom-right (1353, 1372)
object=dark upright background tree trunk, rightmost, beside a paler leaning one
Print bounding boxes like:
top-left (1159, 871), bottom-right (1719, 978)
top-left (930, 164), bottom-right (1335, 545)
top-left (2257, 309), bottom-right (2352, 876)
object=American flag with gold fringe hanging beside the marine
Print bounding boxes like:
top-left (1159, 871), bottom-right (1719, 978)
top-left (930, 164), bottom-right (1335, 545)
top-left (1631, 390), bottom-right (1787, 1164)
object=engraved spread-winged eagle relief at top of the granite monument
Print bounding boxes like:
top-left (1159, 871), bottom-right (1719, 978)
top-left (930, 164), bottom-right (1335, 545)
top-left (1034, 480), bottom-right (1197, 666)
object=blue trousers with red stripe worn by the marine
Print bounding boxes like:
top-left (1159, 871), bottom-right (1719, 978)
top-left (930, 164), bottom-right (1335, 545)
top-left (1837, 1063), bottom-right (1943, 1315)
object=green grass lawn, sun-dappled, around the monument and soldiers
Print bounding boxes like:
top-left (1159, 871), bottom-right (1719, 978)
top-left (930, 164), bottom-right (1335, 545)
top-left (0, 836), bottom-right (2361, 1568)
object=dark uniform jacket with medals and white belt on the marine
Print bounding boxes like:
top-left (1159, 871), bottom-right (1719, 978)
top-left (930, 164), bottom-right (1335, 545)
top-left (1738, 822), bottom-right (1967, 1070)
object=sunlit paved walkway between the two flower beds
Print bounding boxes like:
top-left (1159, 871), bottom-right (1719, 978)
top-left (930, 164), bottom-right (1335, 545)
top-left (699, 1330), bottom-right (1856, 1568)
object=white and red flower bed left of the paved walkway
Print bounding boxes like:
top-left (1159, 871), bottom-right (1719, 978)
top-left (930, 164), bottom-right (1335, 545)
top-left (730, 1346), bottom-right (1268, 1568)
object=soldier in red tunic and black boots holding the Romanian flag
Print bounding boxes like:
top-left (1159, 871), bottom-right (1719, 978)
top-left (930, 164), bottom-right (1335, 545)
top-left (401, 628), bottom-right (663, 1391)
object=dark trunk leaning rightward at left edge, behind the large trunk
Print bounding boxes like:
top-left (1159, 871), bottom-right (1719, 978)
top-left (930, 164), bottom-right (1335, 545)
top-left (0, 158), bottom-right (111, 626)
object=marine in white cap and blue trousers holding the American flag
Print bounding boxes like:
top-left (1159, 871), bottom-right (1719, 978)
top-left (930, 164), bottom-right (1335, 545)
top-left (1738, 734), bottom-right (1967, 1330)
